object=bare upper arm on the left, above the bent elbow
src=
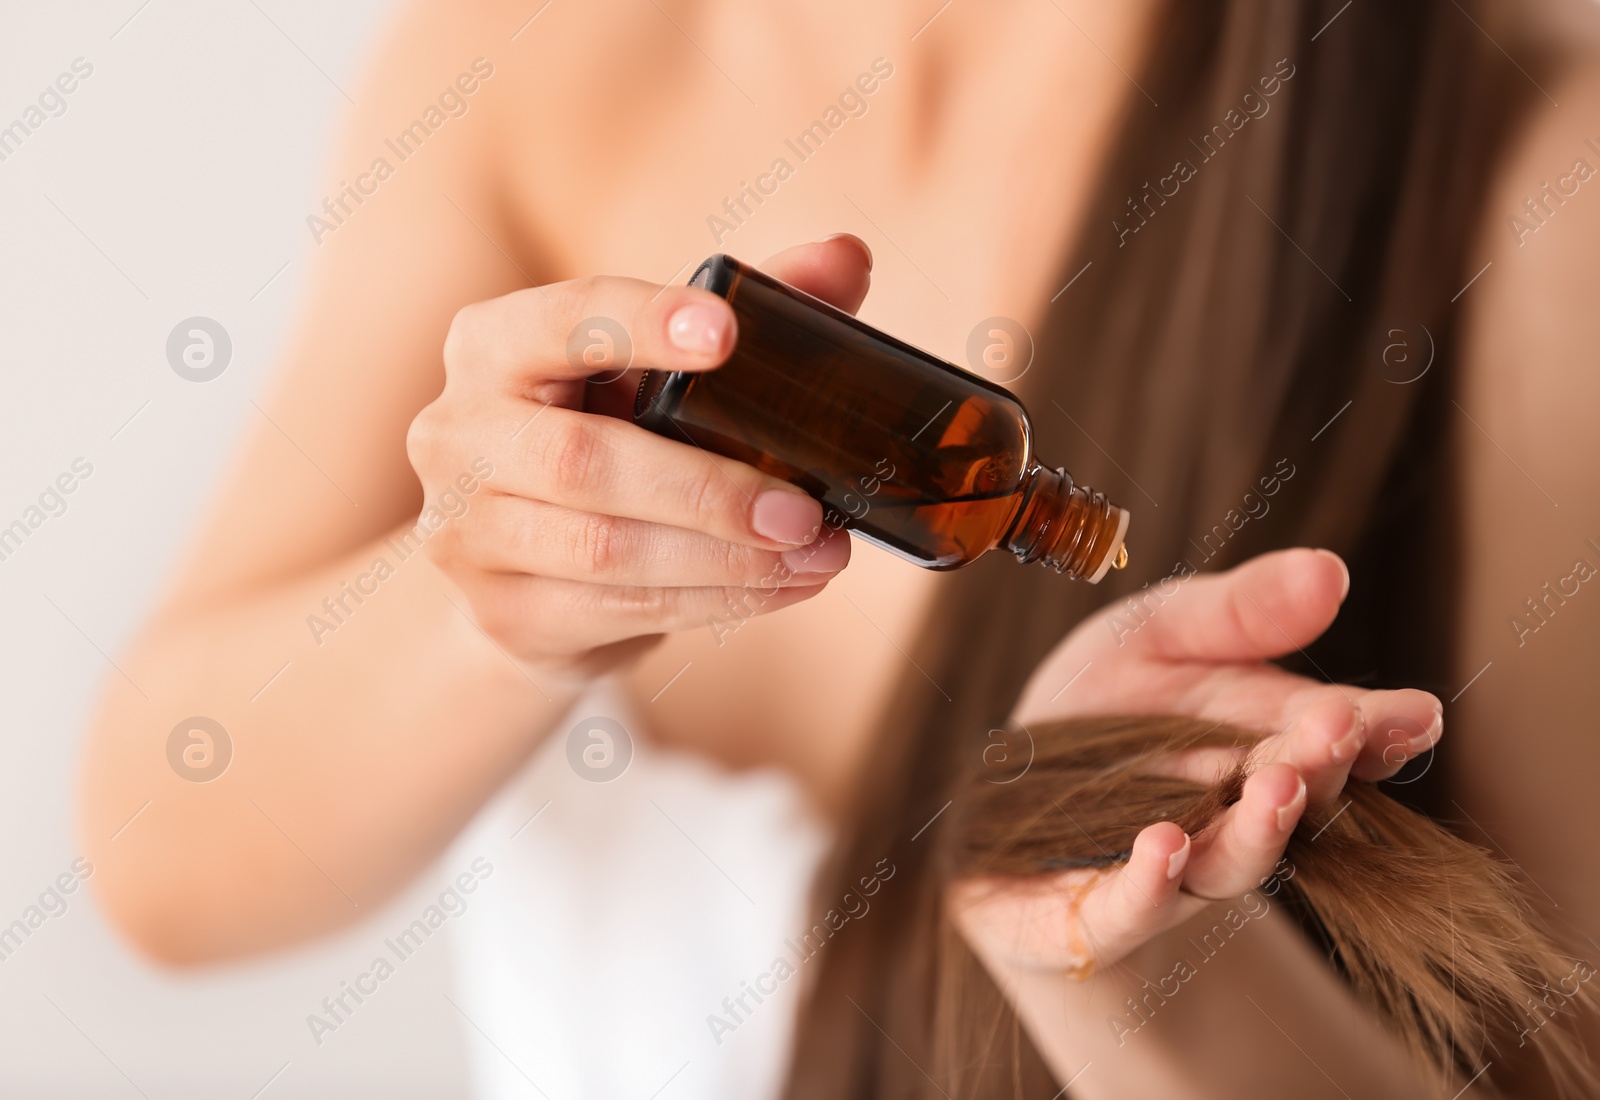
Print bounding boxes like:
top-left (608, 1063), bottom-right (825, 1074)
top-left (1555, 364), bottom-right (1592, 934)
top-left (171, 2), bottom-right (534, 604)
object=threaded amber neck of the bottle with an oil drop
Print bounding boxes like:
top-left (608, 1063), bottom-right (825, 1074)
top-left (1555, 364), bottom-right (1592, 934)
top-left (1002, 462), bottom-right (1128, 584)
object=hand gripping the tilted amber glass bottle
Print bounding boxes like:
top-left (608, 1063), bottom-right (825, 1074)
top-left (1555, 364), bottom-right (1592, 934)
top-left (406, 237), bottom-right (870, 672)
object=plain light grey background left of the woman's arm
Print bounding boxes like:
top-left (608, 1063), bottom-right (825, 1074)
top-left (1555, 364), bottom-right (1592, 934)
top-left (0, 0), bottom-right (470, 1100)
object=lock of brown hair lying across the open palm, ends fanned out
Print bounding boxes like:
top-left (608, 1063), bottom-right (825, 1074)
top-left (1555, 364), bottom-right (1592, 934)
top-left (925, 716), bottom-right (1600, 1098)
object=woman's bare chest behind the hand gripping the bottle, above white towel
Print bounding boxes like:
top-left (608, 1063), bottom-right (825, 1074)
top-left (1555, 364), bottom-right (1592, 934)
top-left (492, 3), bottom-right (1142, 804)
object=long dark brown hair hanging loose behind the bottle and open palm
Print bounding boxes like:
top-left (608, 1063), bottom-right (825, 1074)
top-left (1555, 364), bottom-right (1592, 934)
top-left (787, 0), bottom-right (1529, 1100)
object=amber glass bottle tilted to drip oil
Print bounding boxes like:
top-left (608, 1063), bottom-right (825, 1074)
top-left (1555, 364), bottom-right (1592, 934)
top-left (634, 256), bottom-right (1128, 580)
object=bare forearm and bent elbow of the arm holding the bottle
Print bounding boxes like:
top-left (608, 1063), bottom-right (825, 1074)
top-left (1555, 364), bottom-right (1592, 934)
top-left (82, 524), bottom-right (578, 961)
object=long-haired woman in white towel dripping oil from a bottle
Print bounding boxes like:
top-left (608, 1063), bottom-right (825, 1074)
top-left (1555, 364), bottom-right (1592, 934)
top-left (85, 0), bottom-right (1600, 1097)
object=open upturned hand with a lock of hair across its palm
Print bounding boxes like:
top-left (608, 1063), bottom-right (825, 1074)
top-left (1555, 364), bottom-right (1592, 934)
top-left (949, 550), bottom-right (1443, 974)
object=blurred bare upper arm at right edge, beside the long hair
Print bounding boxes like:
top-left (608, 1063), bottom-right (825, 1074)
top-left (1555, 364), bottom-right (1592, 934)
top-left (1442, 55), bottom-right (1600, 980)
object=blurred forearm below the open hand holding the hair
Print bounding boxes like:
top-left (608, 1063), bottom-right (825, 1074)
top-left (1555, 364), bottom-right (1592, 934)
top-left (990, 897), bottom-right (1459, 1100)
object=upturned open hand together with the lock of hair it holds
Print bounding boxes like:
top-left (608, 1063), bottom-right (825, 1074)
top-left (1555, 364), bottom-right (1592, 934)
top-left (938, 550), bottom-right (1594, 1095)
